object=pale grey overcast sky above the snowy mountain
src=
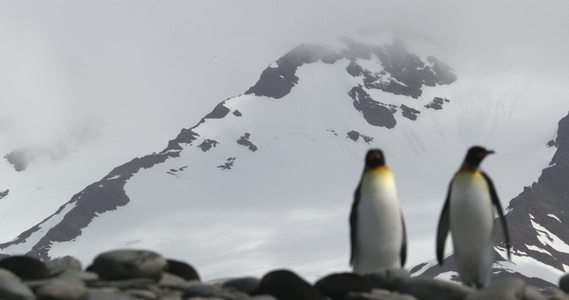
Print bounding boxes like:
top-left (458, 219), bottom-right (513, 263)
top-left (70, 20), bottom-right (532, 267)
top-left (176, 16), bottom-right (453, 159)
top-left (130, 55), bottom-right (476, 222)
top-left (0, 0), bottom-right (569, 278)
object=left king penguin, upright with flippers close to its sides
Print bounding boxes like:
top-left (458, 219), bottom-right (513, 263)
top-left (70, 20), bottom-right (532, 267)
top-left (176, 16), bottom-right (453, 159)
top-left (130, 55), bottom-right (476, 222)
top-left (350, 149), bottom-right (407, 274)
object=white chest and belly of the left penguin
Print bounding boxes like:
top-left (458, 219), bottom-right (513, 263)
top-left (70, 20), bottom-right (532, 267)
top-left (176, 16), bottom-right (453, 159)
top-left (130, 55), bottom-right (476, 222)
top-left (354, 168), bottom-right (403, 273)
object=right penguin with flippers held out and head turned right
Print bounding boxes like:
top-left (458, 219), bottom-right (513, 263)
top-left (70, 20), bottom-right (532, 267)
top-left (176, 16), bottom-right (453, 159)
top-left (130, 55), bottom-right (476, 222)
top-left (436, 146), bottom-right (511, 288)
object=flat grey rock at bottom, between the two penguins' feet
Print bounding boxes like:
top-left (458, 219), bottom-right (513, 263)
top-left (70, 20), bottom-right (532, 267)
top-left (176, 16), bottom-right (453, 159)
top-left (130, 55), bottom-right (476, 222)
top-left (399, 277), bottom-right (473, 300)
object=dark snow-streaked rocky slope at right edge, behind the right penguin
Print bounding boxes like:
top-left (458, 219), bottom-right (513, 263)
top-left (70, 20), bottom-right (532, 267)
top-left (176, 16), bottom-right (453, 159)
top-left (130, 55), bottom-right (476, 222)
top-left (411, 111), bottom-right (569, 287)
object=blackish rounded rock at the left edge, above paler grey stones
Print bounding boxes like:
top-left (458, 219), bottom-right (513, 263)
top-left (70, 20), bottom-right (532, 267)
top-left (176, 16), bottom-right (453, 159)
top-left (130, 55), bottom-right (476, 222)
top-left (0, 255), bottom-right (49, 280)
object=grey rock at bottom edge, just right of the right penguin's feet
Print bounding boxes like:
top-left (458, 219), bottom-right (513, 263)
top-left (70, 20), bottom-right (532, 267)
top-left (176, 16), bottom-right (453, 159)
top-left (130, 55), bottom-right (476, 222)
top-left (464, 277), bottom-right (525, 300)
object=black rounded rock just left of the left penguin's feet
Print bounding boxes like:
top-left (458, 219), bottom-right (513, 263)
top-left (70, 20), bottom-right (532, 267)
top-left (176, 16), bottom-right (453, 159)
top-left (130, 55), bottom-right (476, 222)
top-left (314, 273), bottom-right (371, 300)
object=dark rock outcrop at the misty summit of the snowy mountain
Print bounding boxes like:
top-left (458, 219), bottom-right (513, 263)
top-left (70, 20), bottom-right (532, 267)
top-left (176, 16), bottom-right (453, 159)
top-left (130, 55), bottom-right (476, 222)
top-left (246, 40), bottom-right (456, 122)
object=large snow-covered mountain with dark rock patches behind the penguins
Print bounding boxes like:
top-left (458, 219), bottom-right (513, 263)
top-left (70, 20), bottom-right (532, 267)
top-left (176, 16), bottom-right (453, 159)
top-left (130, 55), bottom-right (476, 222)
top-left (0, 39), bottom-right (569, 280)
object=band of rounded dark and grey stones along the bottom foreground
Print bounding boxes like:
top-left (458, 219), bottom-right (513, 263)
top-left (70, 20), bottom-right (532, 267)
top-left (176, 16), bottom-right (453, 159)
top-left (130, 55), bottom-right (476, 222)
top-left (0, 249), bottom-right (569, 300)
